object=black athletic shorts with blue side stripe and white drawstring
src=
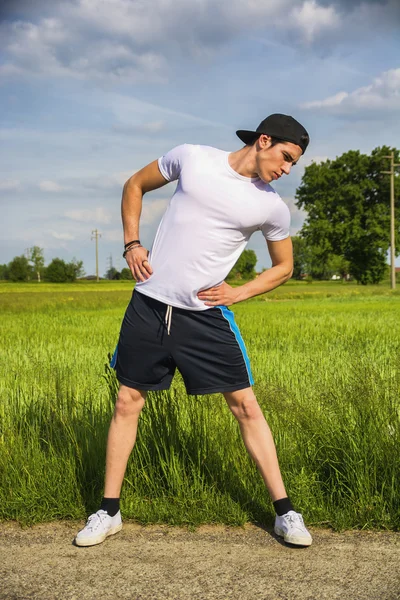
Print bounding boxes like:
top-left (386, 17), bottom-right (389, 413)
top-left (111, 291), bottom-right (253, 394)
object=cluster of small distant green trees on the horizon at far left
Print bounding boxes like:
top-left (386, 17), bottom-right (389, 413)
top-left (0, 246), bottom-right (84, 283)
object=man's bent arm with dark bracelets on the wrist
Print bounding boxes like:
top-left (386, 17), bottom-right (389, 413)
top-left (121, 160), bottom-right (168, 281)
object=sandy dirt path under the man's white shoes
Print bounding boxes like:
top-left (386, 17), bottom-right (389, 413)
top-left (0, 522), bottom-right (400, 600)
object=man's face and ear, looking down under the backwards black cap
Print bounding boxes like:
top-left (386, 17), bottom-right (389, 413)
top-left (256, 135), bottom-right (302, 183)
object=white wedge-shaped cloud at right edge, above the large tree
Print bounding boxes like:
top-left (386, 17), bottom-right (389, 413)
top-left (301, 68), bottom-right (400, 114)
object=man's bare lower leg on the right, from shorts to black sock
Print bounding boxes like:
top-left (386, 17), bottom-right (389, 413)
top-left (224, 387), bottom-right (287, 502)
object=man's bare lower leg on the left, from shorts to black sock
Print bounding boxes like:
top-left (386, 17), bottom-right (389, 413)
top-left (104, 385), bottom-right (146, 498)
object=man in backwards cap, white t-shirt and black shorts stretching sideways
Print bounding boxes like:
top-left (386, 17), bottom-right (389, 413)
top-left (75, 114), bottom-right (312, 546)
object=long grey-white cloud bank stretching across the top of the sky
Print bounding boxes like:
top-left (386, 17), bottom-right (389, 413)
top-left (0, 0), bottom-right (354, 84)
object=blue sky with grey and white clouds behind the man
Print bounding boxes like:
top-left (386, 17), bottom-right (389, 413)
top-left (0, 0), bottom-right (400, 275)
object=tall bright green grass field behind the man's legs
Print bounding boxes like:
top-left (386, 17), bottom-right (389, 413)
top-left (0, 282), bottom-right (400, 529)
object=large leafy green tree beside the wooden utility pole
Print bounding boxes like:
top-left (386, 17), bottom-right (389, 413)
top-left (296, 146), bottom-right (400, 284)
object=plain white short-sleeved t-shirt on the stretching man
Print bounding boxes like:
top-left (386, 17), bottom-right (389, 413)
top-left (136, 144), bottom-right (290, 310)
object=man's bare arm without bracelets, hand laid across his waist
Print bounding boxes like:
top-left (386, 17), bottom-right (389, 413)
top-left (198, 237), bottom-right (293, 306)
